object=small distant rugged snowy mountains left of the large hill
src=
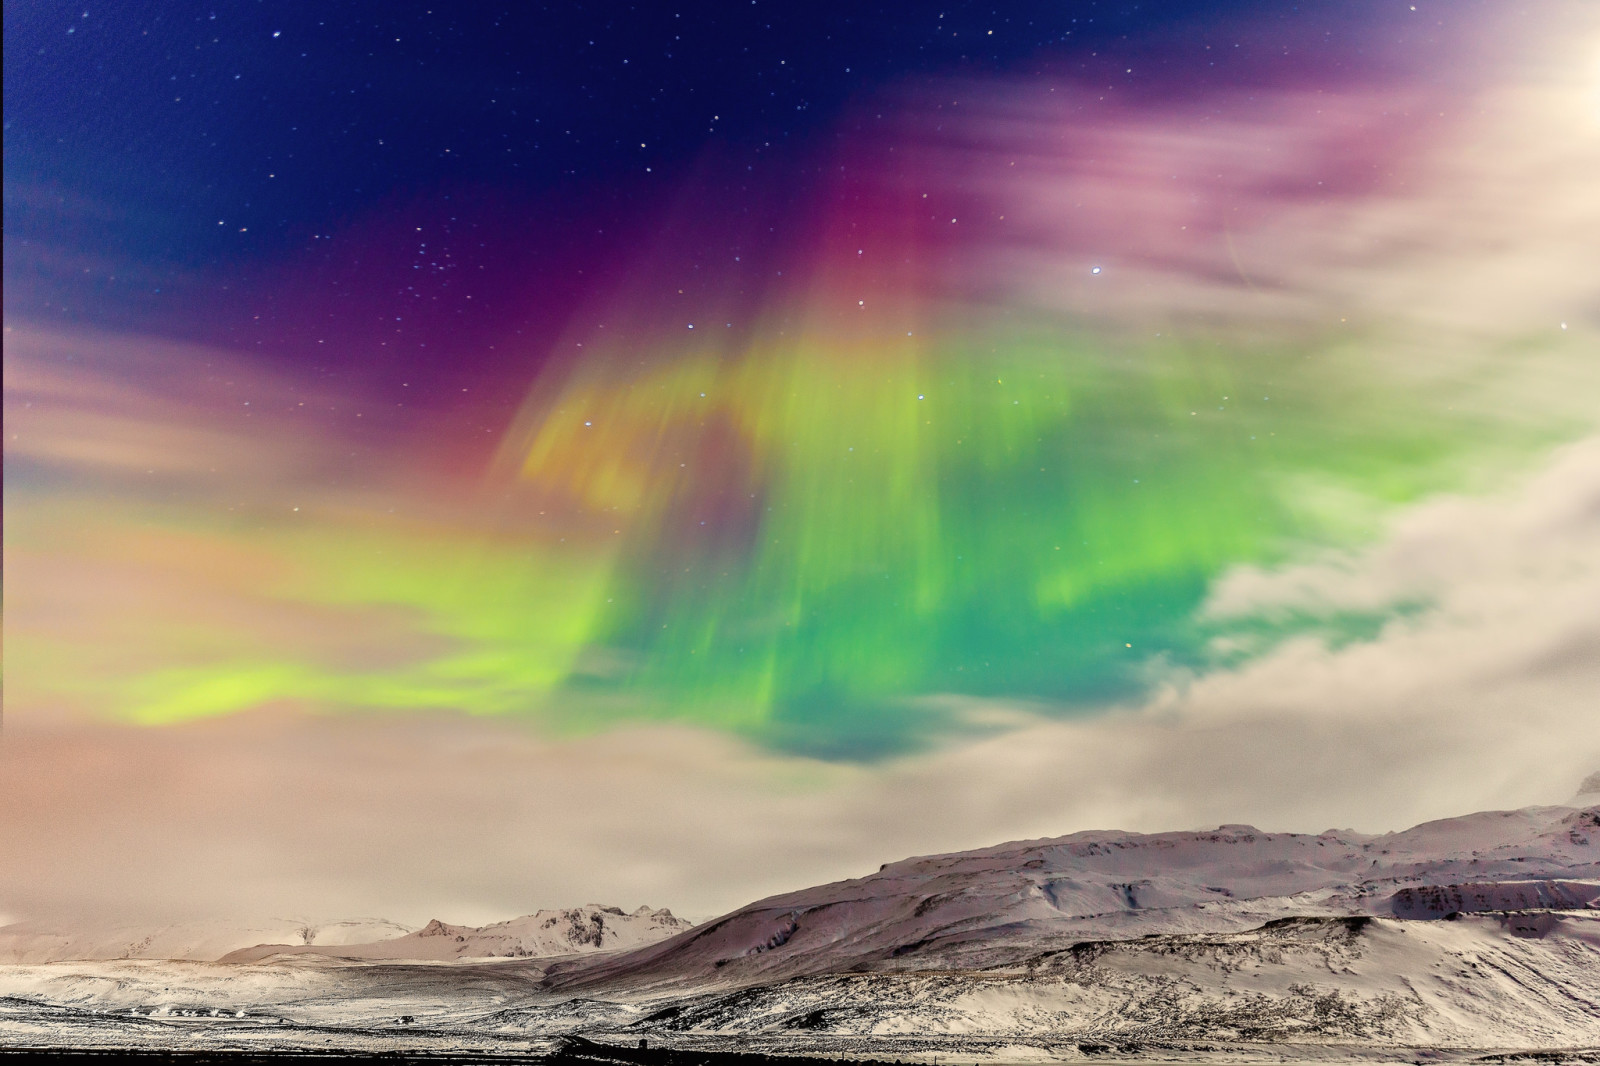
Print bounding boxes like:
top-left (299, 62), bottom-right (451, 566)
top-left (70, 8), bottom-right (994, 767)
top-left (221, 903), bottom-right (690, 964)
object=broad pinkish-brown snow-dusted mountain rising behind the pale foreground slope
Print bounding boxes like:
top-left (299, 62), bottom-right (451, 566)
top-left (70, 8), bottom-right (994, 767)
top-left (547, 807), bottom-right (1600, 991)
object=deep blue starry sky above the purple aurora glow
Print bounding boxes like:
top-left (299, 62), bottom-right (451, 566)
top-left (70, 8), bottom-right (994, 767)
top-left (5, 0), bottom-right (1452, 388)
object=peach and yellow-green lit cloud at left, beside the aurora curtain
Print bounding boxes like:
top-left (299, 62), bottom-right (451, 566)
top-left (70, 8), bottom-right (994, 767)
top-left (5, 325), bottom-right (617, 723)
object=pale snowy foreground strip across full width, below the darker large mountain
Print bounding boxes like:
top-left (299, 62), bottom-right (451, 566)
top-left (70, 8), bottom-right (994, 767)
top-left (9, 912), bottom-right (1600, 1063)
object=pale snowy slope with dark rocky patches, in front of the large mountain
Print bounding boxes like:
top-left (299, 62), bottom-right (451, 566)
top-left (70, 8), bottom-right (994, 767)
top-left (629, 914), bottom-right (1600, 1055)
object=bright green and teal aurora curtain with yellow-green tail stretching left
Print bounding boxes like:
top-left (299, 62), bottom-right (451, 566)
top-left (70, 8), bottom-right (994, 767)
top-left (8, 307), bottom-right (1573, 759)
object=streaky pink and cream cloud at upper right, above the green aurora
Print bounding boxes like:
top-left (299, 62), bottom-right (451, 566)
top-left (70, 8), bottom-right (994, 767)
top-left (926, 5), bottom-right (1600, 355)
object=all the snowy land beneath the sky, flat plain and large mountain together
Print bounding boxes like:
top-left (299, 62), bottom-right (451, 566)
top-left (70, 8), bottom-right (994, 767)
top-left (0, 807), bottom-right (1600, 1061)
